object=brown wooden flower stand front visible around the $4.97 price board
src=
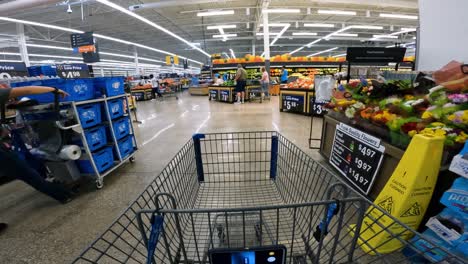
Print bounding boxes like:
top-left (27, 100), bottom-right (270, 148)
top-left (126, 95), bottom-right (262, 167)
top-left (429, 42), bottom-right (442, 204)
top-left (320, 114), bottom-right (404, 200)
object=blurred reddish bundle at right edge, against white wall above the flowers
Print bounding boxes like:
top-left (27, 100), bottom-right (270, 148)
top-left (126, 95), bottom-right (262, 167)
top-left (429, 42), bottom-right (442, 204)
top-left (432, 61), bottom-right (468, 91)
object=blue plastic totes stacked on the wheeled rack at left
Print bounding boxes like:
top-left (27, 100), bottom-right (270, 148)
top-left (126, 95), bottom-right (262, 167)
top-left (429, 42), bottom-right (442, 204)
top-left (11, 75), bottom-right (136, 177)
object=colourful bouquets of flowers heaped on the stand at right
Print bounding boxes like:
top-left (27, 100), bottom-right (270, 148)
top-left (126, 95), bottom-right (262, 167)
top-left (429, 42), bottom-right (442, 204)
top-left (327, 60), bottom-right (468, 148)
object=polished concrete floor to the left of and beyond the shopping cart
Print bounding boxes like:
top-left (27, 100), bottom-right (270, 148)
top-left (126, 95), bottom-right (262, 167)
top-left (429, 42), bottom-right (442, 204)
top-left (0, 92), bottom-right (320, 263)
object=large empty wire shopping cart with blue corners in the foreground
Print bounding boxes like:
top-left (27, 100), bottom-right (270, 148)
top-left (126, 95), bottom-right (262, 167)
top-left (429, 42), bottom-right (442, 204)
top-left (74, 132), bottom-right (463, 263)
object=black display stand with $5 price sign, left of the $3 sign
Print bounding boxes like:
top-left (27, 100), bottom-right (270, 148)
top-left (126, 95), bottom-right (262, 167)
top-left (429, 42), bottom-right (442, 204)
top-left (279, 88), bottom-right (314, 115)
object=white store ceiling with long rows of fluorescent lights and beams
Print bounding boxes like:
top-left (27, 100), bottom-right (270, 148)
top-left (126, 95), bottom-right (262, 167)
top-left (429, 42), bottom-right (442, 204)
top-left (0, 0), bottom-right (418, 66)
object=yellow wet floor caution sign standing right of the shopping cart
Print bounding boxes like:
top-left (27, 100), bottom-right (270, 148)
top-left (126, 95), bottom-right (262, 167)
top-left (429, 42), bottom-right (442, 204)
top-left (349, 135), bottom-right (444, 255)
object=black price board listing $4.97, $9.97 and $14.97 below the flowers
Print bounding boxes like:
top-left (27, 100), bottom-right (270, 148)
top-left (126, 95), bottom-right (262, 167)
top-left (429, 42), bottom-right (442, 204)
top-left (329, 123), bottom-right (385, 194)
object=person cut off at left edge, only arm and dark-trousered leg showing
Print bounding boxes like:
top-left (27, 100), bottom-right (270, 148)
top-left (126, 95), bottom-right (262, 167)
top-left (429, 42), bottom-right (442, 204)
top-left (0, 84), bottom-right (72, 232)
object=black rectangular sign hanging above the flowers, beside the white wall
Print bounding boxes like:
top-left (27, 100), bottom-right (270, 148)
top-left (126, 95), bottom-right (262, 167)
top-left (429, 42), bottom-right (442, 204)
top-left (346, 47), bottom-right (406, 63)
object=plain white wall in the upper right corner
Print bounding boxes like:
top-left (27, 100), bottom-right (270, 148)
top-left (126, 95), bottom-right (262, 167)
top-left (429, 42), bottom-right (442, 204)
top-left (417, 0), bottom-right (468, 71)
